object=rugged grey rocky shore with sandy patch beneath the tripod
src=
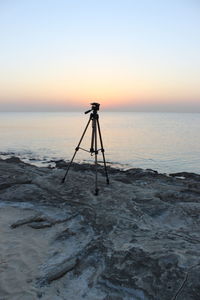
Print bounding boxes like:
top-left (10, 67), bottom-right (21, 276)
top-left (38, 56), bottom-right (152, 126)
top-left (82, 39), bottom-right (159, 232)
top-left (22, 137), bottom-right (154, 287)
top-left (0, 157), bottom-right (200, 300)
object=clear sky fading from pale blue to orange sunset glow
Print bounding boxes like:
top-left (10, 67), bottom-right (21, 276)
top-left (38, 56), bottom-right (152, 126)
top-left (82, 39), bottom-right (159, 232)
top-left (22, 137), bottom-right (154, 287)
top-left (0, 0), bottom-right (200, 112)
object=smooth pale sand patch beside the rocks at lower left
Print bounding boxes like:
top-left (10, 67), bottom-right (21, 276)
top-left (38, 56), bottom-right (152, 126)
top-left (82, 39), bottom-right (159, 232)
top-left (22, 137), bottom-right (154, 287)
top-left (0, 207), bottom-right (49, 300)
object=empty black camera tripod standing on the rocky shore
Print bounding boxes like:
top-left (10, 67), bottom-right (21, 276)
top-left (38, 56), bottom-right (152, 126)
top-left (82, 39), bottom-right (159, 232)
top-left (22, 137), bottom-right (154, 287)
top-left (62, 103), bottom-right (109, 195)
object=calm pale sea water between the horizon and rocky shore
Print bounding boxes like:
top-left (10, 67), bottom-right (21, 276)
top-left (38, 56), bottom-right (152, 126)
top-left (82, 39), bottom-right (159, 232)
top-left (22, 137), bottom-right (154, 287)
top-left (0, 112), bottom-right (200, 173)
